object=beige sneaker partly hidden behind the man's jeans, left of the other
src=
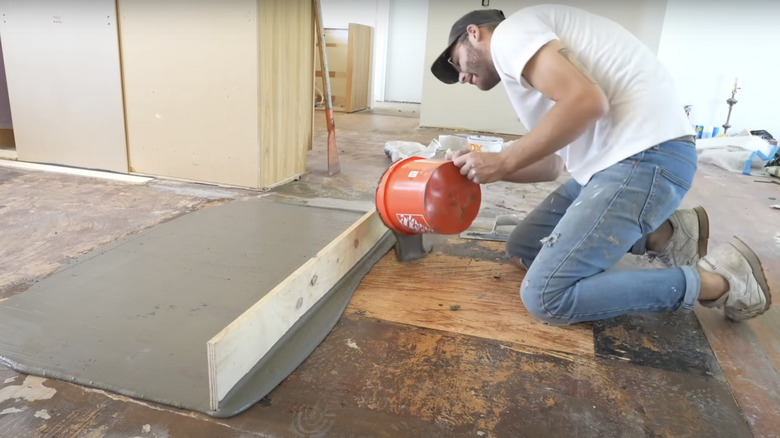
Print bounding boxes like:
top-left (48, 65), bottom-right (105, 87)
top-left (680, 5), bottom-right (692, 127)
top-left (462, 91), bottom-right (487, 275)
top-left (647, 207), bottom-right (710, 268)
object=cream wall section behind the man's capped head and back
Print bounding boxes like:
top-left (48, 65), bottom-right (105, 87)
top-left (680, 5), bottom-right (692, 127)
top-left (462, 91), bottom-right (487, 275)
top-left (420, 0), bottom-right (666, 134)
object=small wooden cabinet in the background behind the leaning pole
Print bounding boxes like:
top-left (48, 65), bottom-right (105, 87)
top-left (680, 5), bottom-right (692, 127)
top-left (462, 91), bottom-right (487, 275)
top-left (315, 23), bottom-right (373, 113)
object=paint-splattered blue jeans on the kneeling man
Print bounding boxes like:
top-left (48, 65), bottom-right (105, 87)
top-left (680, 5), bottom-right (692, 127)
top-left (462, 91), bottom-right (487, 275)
top-left (506, 141), bottom-right (701, 325)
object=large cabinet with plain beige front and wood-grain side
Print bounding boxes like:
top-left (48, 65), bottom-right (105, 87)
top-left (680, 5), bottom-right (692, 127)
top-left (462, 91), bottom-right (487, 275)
top-left (118, 0), bottom-right (313, 188)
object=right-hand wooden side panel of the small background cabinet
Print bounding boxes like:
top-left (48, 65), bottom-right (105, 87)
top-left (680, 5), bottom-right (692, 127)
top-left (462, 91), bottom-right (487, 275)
top-left (346, 23), bottom-right (373, 113)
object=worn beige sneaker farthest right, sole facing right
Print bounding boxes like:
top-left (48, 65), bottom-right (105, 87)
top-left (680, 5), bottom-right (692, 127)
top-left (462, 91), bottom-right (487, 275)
top-left (699, 237), bottom-right (772, 321)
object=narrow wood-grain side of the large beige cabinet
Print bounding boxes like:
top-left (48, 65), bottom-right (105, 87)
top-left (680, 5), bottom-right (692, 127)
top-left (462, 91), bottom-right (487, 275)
top-left (258, 0), bottom-right (314, 187)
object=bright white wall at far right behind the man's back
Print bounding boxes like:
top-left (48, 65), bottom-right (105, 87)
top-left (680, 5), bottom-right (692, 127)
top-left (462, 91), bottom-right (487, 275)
top-left (658, 0), bottom-right (780, 137)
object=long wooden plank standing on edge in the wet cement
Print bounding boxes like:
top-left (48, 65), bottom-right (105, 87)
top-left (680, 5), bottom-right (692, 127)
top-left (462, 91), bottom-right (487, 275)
top-left (207, 210), bottom-right (387, 411)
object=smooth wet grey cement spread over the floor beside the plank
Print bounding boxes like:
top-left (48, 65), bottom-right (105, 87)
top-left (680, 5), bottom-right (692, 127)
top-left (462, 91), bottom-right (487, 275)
top-left (0, 198), bottom-right (380, 412)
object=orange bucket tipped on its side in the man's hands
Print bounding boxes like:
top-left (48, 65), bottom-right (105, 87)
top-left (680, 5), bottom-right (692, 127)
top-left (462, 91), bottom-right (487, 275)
top-left (376, 157), bottom-right (482, 234)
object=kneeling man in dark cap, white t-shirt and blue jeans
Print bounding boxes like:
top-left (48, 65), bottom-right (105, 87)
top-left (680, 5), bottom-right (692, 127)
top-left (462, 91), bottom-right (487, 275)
top-left (431, 5), bottom-right (771, 325)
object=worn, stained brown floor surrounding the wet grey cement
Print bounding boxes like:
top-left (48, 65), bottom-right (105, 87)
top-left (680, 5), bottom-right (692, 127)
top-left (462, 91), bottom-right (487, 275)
top-left (0, 112), bottom-right (780, 437)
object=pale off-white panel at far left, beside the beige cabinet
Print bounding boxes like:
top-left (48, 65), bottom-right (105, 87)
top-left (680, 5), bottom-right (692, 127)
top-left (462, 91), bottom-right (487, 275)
top-left (0, 0), bottom-right (127, 172)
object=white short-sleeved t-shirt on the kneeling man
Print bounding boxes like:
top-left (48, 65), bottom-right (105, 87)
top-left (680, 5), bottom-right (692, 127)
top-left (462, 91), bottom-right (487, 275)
top-left (490, 5), bottom-right (694, 185)
